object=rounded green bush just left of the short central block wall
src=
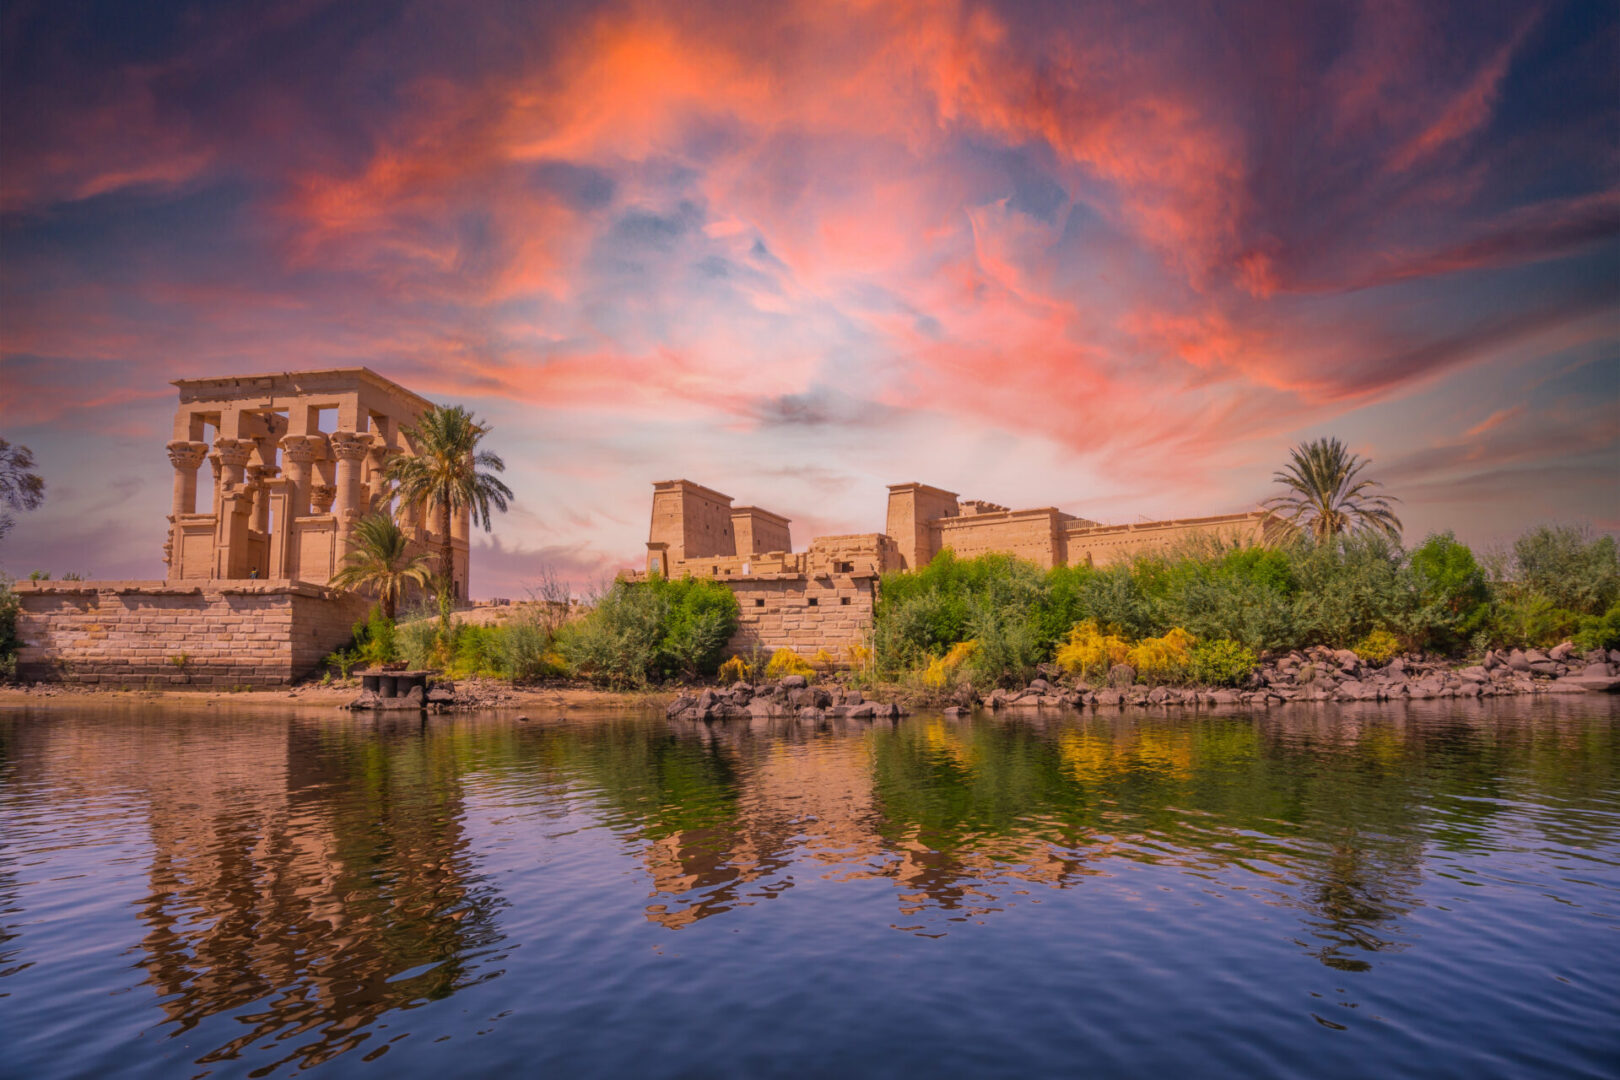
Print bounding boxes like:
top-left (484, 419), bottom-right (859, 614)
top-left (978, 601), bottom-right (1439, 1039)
top-left (557, 576), bottom-right (740, 685)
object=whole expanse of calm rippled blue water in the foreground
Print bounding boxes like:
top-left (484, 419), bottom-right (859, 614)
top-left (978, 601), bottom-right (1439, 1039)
top-left (0, 696), bottom-right (1620, 1080)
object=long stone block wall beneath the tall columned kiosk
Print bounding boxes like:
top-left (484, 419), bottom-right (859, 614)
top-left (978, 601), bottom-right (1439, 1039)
top-left (15, 581), bottom-right (369, 688)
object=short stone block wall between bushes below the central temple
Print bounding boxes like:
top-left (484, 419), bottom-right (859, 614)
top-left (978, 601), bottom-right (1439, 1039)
top-left (723, 573), bottom-right (876, 665)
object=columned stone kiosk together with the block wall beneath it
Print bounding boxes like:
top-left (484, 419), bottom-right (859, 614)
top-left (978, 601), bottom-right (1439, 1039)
top-left (15, 368), bottom-right (456, 688)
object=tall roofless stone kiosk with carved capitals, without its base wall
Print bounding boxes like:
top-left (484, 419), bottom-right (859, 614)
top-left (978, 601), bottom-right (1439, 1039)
top-left (164, 368), bottom-right (471, 597)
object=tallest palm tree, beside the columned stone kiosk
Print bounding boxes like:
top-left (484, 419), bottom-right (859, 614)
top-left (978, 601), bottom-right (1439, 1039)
top-left (387, 405), bottom-right (512, 588)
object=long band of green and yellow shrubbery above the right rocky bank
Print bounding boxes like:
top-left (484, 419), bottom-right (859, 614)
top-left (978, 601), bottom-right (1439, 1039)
top-left (875, 526), bottom-right (1620, 685)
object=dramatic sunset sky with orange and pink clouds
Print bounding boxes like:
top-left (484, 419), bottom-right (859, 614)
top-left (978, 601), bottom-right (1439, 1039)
top-left (0, 0), bottom-right (1620, 597)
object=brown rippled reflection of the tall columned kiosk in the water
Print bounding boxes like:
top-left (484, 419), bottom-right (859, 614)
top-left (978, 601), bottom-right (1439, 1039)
top-left (11, 719), bottom-right (501, 1067)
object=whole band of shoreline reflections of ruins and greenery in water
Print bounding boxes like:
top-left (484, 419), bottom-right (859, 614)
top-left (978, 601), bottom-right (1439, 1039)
top-left (0, 703), bottom-right (1620, 1075)
